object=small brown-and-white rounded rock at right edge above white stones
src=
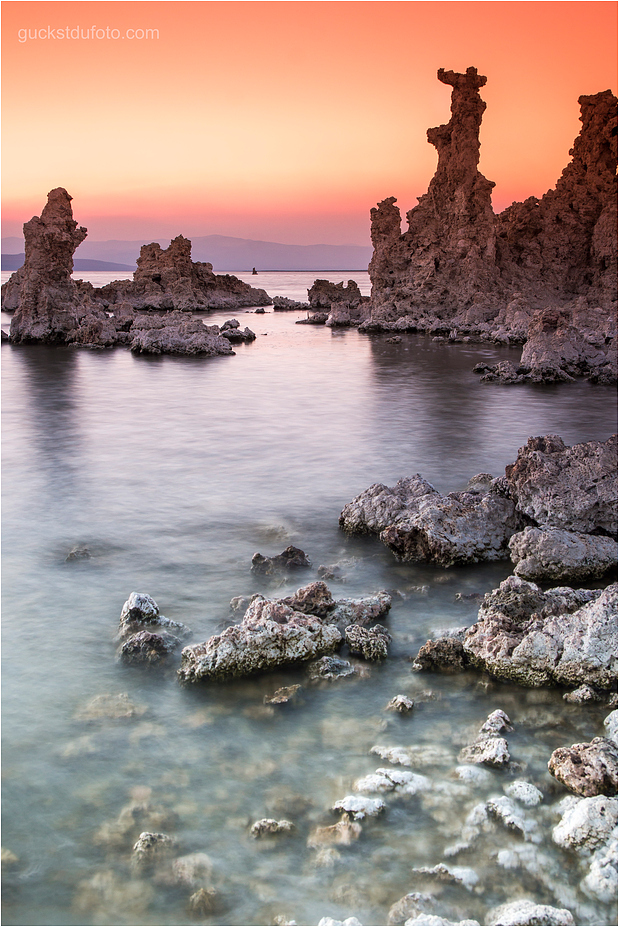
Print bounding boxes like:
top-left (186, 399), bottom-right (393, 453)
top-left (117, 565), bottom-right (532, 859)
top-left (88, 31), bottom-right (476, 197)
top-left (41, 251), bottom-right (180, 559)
top-left (548, 737), bottom-right (617, 798)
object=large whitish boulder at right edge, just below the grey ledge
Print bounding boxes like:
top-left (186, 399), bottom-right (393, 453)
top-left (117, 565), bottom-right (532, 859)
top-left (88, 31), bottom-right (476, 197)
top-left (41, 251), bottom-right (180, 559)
top-left (463, 576), bottom-right (617, 690)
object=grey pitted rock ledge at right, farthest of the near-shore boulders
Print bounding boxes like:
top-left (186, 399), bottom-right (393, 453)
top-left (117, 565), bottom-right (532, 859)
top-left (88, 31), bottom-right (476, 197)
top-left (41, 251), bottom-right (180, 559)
top-left (339, 435), bottom-right (617, 582)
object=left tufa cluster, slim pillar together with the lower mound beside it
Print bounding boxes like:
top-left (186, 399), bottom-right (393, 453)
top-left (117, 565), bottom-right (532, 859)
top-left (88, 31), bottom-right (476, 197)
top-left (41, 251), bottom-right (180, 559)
top-left (2, 187), bottom-right (270, 356)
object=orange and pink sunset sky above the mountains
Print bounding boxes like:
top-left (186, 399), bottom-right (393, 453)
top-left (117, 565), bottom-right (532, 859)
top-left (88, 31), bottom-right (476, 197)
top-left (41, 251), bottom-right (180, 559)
top-left (2, 0), bottom-right (617, 245)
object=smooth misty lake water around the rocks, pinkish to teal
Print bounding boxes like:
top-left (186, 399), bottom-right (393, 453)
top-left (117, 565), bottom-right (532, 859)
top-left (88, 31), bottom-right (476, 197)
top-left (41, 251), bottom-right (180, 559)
top-left (2, 273), bottom-right (616, 925)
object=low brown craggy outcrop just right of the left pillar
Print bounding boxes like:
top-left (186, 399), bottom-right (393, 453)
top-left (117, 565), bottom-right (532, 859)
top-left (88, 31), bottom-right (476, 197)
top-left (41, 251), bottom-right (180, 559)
top-left (97, 235), bottom-right (271, 312)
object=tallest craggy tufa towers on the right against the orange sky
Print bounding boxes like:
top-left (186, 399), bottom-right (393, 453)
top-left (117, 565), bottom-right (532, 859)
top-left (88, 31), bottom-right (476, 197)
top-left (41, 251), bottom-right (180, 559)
top-left (362, 68), bottom-right (617, 382)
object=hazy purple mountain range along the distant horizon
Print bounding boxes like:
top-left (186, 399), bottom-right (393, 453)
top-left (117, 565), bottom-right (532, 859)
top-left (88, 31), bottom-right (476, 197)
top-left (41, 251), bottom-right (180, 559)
top-left (2, 235), bottom-right (372, 273)
